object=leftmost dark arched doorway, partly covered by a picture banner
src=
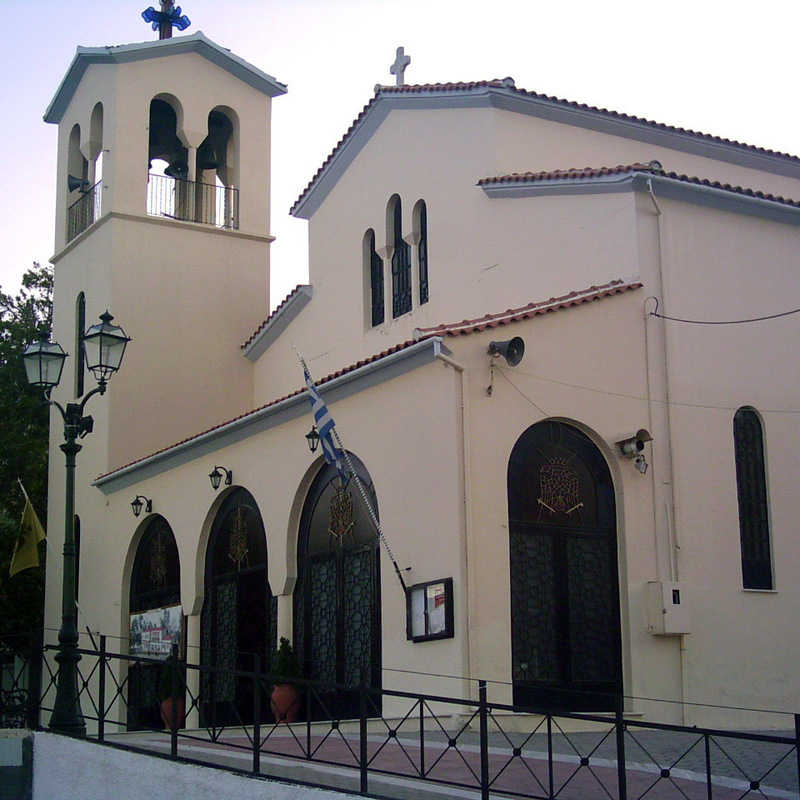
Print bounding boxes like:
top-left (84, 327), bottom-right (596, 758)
top-left (128, 514), bottom-right (181, 730)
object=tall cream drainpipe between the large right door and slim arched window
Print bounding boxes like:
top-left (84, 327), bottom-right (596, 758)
top-left (644, 178), bottom-right (689, 725)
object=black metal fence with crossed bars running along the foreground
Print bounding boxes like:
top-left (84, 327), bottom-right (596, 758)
top-left (0, 636), bottom-right (800, 800)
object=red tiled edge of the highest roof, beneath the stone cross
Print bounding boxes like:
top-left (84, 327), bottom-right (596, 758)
top-left (289, 78), bottom-right (800, 214)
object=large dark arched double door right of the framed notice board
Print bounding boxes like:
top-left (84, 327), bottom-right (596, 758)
top-left (508, 421), bottom-right (622, 711)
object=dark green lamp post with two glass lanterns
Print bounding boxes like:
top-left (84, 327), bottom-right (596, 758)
top-left (22, 311), bottom-right (130, 736)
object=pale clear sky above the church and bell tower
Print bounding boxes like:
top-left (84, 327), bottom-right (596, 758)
top-left (0, 0), bottom-right (800, 307)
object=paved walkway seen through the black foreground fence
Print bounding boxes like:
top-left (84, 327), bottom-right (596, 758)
top-left (113, 726), bottom-right (800, 800)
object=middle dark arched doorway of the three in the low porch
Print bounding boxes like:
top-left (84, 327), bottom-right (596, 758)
top-left (200, 488), bottom-right (277, 725)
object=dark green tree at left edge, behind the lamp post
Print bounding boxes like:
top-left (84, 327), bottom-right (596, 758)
top-left (0, 263), bottom-right (53, 635)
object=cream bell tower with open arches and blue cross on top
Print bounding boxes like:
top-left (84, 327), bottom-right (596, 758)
top-left (44, 29), bottom-right (286, 468)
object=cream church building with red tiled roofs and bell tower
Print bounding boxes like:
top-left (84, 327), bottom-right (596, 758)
top-left (45, 23), bottom-right (800, 728)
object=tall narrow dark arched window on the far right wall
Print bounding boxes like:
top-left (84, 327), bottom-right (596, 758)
top-left (733, 407), bottom-right (773, 589)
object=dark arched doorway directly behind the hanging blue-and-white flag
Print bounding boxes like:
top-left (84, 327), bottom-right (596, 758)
top-left (294, 455), bottom-right (381, 719)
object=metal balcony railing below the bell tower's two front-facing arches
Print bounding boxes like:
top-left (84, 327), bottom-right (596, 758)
top-left (147, 173), bottom-right (239, 230)
